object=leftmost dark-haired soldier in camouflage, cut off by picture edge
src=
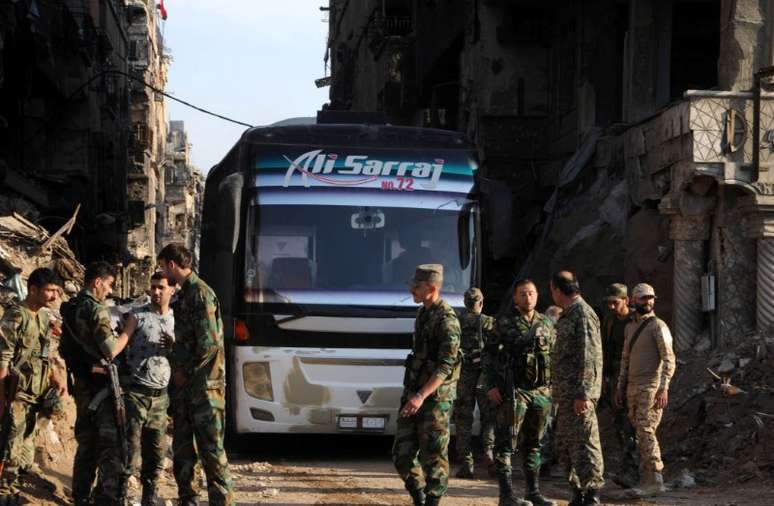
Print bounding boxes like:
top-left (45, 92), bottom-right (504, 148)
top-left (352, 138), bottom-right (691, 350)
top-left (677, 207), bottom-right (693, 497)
top-left (0, 268), bottom-right (67, 506)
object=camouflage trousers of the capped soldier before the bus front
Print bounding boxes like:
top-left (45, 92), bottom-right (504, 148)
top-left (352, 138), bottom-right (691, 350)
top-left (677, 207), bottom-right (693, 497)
top-left (392, 399), bottom-right (451, 497)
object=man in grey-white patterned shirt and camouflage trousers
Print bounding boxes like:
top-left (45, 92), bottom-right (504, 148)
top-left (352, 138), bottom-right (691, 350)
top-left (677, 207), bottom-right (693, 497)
top-left (116, 272), bottom-right (175, 506)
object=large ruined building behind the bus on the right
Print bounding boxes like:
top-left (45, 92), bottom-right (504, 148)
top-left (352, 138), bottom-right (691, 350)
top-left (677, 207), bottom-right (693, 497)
top-left (326, 0), bottom-right (774, 350)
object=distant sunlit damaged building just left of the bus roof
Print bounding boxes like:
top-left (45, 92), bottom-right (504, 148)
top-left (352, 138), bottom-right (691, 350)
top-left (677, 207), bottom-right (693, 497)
top-left (164, 121), bottom-right (204, 259)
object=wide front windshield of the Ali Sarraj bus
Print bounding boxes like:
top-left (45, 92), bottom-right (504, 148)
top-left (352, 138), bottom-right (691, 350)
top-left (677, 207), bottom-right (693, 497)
top-left (245, 199), bottom-right (475, 304)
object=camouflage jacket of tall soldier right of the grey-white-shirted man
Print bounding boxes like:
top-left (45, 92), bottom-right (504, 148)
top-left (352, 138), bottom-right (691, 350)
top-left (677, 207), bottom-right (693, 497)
top-left (169, 273), bottom-right (226, 390)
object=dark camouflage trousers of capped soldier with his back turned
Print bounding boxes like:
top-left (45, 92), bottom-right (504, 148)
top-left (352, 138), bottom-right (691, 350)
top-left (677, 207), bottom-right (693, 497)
top-left (452, 364), bottom-right (495, 466)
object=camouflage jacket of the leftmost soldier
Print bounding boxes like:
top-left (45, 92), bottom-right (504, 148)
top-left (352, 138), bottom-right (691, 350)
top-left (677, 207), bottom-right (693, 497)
top-left (0, 303), bottom-right (49, 397)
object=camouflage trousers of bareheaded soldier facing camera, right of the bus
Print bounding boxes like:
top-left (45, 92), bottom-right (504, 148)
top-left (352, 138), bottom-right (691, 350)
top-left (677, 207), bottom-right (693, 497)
top-left (495, 388), bottom-right (551, 475)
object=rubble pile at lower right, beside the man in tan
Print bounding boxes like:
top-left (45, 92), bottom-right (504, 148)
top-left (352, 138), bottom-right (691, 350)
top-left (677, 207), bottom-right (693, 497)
top-left (659, 335), bottom-right (774, 485)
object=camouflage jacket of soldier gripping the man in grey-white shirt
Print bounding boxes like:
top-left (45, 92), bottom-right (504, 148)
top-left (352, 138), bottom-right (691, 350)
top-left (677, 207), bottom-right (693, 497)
top-left (59, 289), bottom-right (117, 375)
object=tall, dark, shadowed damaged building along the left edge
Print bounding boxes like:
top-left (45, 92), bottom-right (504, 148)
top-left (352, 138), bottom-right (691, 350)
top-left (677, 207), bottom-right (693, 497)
top-left (0, 0), bottom-right (169, 288)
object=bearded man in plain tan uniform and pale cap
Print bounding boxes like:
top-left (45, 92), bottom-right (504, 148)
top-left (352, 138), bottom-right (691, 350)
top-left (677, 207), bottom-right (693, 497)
top-left (615, 283), bottom-right (675, 495)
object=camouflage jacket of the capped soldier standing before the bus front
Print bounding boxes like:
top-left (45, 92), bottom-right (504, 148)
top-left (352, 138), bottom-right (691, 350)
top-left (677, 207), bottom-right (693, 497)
top-left (404, 299), bottom-right (460, 401)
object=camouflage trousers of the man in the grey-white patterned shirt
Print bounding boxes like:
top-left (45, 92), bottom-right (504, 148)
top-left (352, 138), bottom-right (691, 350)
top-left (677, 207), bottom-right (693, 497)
top-left (124, 387), bottom-right (169, 491)
